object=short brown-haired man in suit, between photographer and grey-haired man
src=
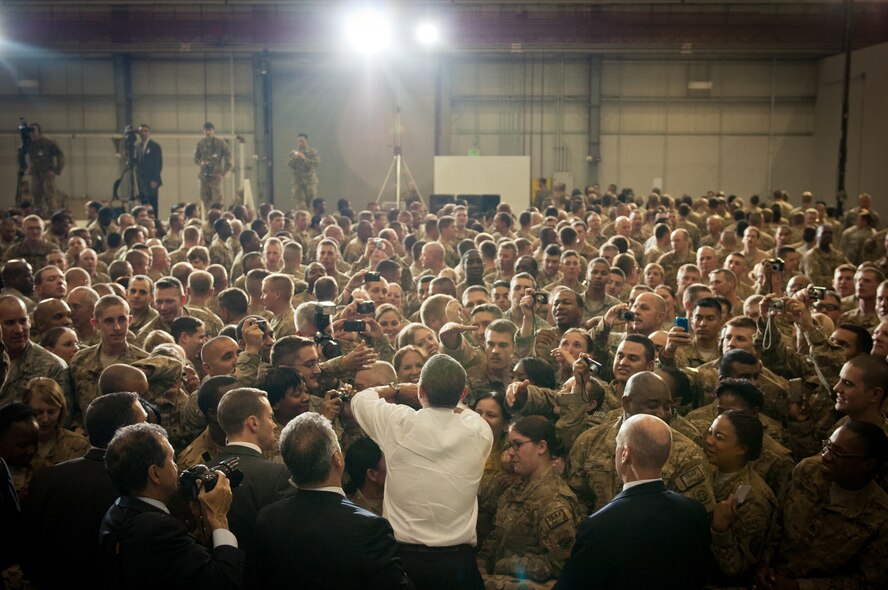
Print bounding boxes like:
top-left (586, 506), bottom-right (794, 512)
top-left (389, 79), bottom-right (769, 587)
top-left (216, 387), bottom-right (296, 553)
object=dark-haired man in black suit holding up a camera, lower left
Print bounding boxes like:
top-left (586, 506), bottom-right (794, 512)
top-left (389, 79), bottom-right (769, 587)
top-left (95, 423), bottom-right (244, 590)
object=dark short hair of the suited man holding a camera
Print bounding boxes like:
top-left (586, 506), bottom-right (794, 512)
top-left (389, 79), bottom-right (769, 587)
top-left (105, 422), bottom-right (168, 496)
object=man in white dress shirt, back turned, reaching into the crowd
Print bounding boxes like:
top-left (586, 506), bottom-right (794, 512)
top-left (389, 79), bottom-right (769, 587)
top-left (351, 354), bottom-right (493, 590)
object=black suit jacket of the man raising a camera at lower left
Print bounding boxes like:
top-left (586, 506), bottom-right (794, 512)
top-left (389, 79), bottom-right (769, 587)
top-left (99, 496), bottom-right (244, 590)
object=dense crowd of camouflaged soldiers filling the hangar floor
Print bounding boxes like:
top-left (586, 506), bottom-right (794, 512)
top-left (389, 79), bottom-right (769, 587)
top-left (0, 186), bottom-right (888, 588)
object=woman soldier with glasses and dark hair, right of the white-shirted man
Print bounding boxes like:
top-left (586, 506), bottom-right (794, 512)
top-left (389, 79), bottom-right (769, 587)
top-left (478, 416), bottom-right (581, 582)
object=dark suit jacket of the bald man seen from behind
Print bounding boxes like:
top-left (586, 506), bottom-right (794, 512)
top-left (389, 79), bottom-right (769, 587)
top-left (555, 481), bottom-right (711, 590)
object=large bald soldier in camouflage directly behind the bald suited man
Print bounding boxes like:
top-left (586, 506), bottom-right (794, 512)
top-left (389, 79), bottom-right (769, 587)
top-left (565, 371), bottom-right (714, 514)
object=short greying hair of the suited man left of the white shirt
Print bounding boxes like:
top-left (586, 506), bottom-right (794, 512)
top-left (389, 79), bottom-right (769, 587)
top-left (280, 412), bottom-right (340, 486)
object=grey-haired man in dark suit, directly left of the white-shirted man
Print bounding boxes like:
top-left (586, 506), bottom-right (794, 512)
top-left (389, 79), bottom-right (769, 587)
top-left (251, 412), bottom-right (414, 590)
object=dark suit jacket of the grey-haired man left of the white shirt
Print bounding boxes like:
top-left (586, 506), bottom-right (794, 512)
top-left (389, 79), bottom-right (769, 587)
top-left (251, 490), bottom-right (413, 590)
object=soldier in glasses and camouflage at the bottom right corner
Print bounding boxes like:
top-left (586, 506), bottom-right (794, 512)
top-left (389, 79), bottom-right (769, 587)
top-left (756, 422), bottom-right (888, 588)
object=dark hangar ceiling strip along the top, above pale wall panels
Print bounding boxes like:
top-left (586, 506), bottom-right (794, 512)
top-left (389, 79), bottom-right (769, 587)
top-left (0, 0), bottom-right (888, 59)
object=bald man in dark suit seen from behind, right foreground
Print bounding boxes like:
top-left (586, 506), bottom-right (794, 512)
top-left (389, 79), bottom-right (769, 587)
top-left (555, 414), bottom-right (710, 590)
